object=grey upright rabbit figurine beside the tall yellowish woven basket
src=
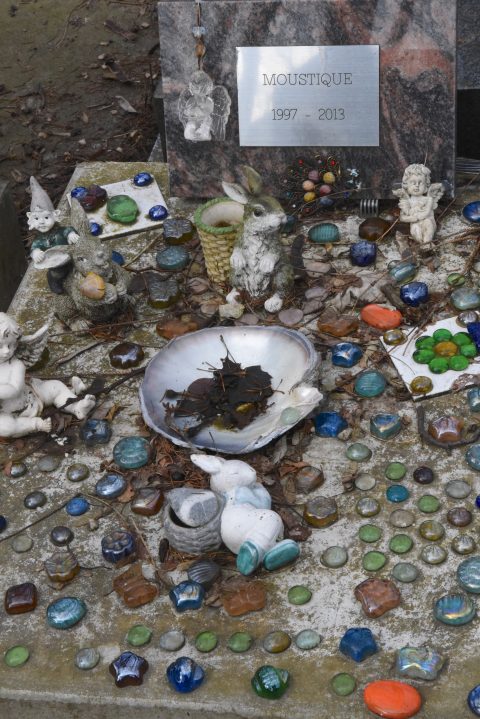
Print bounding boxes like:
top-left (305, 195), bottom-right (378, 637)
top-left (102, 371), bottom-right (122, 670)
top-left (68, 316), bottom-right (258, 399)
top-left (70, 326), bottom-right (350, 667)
top-left (222, 170), bottom-right (294, 312)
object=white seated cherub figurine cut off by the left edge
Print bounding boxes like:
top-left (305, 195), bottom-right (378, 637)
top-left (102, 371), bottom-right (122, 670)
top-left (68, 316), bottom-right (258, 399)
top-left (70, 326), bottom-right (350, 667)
top-left (0, 312), bottom-right (95, 437)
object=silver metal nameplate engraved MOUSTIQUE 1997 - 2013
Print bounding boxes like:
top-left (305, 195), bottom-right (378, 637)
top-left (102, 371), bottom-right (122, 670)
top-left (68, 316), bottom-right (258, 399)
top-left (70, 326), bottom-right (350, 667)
top-left (237, 45), bottom-right (379, 147)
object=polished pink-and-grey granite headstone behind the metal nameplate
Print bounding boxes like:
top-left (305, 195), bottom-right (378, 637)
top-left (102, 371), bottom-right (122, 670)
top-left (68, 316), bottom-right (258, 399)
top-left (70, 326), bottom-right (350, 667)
top-left (159, 0), bottom-right (456, 197)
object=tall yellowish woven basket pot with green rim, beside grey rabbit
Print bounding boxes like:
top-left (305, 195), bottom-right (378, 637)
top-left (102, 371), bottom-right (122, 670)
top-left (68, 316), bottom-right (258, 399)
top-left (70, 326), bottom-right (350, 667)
top-left (193, 197), bottom-right (243, 284)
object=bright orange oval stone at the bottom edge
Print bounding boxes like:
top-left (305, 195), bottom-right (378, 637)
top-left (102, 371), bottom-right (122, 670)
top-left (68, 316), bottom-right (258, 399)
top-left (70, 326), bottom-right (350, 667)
top-left (363, 680), bottom-right (422, 719)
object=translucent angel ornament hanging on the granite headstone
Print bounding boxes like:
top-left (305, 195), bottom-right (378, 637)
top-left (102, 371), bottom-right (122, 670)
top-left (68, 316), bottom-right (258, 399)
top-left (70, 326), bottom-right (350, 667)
top-left (178, 70), bottom-right (231, 142)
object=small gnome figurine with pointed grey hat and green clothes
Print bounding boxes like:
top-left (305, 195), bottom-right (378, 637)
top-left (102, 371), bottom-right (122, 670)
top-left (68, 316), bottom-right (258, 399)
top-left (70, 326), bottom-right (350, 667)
top-left (27, 177), bottom-right (78, 265)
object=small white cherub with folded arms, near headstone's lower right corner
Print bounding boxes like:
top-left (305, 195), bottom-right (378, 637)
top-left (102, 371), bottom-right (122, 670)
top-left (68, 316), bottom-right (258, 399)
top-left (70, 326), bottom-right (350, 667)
top-left (393, 164), bottom-right (444, 250)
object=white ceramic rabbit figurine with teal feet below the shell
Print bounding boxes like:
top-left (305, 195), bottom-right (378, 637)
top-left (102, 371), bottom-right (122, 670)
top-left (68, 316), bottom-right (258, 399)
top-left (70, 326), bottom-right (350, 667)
top-left (190, 454), bottom-right (298, 575)
